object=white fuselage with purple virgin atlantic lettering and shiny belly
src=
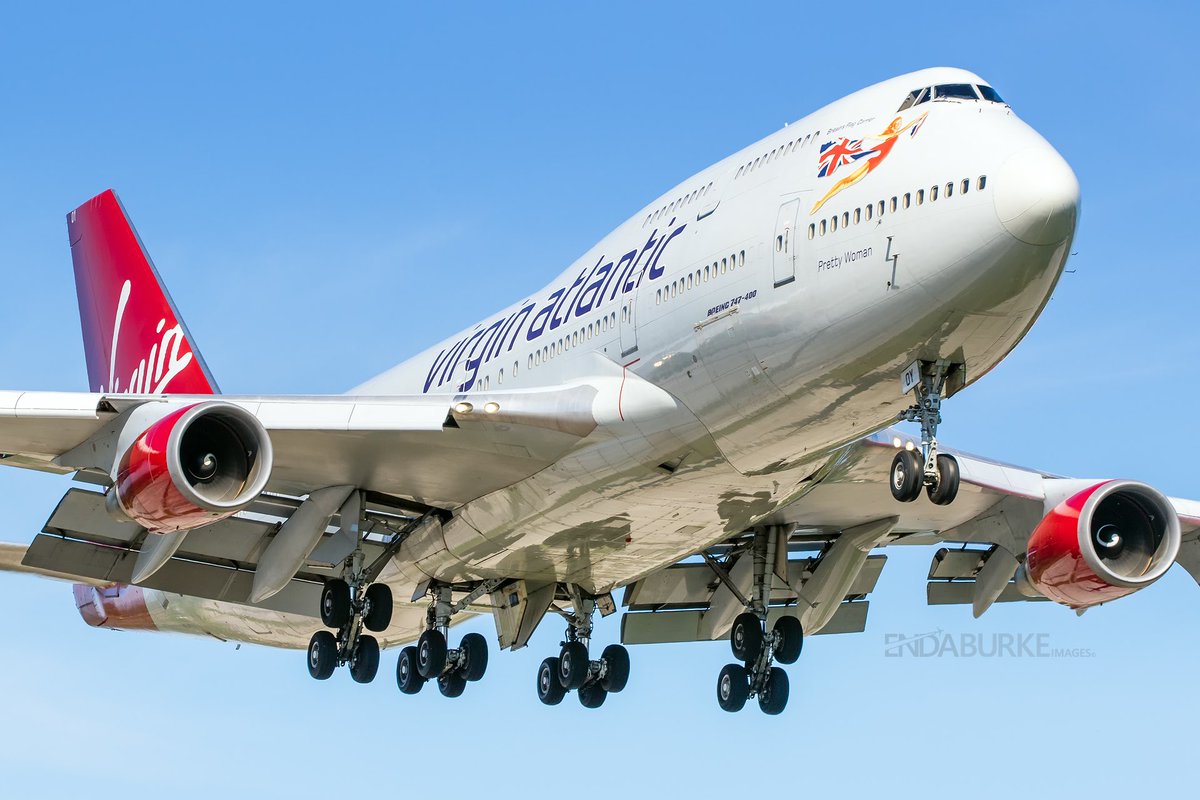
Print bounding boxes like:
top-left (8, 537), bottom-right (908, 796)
top-left (338, 68), bottom-right (1078, 591)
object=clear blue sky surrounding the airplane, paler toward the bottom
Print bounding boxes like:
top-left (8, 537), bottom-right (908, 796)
top-left (0, 2), bottom-right (1200, 798)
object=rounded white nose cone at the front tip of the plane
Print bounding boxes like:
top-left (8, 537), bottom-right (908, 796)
top-left (992, 145), bottom-right (1079, 245)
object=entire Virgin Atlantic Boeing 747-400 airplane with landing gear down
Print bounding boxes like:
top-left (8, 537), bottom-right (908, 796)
top-left (0, 67), bottom-right (1200, 715)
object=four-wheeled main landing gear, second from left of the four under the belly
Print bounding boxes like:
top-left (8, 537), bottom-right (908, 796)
top-left (396, 583), bottom-right (493, 697)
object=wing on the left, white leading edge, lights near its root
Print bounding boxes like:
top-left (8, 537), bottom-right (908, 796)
top-left (0, 379), bottom-right (605, 509)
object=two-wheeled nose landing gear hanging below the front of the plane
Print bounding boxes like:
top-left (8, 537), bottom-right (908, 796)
top-left (888, 361), bottom-right (959, 505)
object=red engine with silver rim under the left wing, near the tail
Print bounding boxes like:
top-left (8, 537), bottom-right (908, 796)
top-left (107, 401), bottom-right (271, 534)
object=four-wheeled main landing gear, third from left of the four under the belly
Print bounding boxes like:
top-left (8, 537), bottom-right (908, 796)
top-left (538, 585), bottom-right (629, 709)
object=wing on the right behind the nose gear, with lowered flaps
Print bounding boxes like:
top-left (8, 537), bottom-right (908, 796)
top-left (622, 429), bottom-right (1200, 644)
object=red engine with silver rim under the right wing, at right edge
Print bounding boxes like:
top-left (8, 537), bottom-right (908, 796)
top-left (1025, 481), bottom-right (1180, 608)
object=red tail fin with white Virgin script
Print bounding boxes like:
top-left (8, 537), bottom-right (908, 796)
top-left (67, 190), bottom-right (218, 395)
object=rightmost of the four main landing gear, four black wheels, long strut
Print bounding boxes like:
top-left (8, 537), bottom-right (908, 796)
top-left (716, 533), bottom-right (804, 715)
